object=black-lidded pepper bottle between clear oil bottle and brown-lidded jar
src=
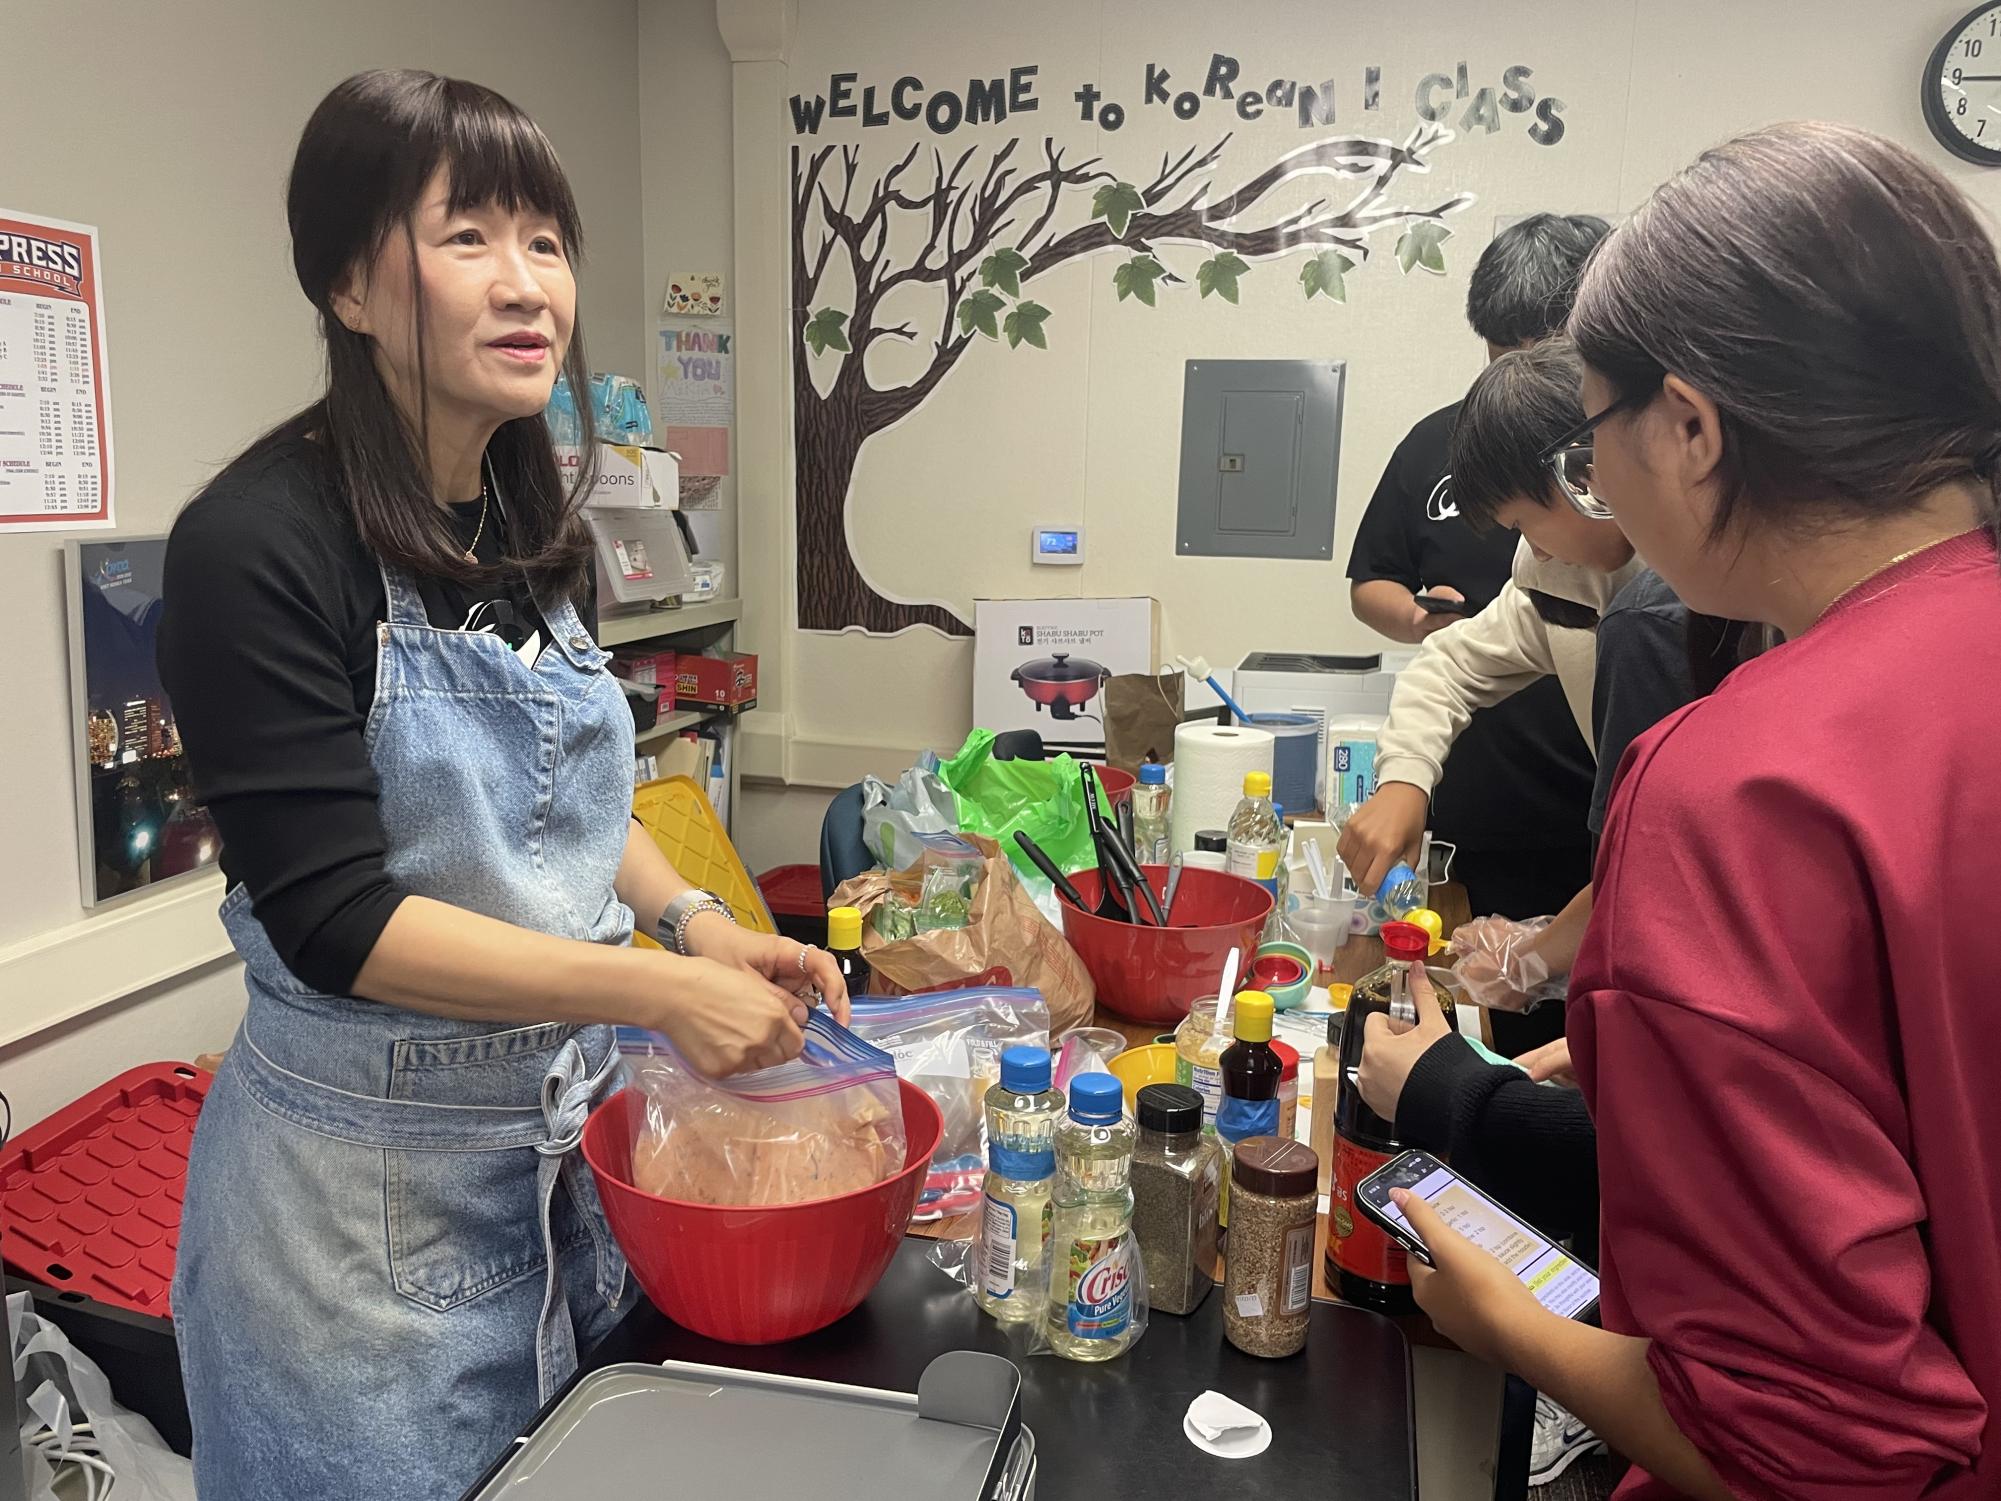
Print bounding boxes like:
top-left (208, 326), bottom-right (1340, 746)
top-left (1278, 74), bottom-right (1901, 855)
top-left (1133, 1085), bottom-right (1223, 1313)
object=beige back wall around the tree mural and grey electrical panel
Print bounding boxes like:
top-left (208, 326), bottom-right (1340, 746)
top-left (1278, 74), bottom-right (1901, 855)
top-left (738, 0), bottom-right (2001, 880)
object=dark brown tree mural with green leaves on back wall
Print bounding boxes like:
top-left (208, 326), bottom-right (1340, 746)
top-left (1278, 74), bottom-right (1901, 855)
top-left (792, 124), bottom-right (1473, 636)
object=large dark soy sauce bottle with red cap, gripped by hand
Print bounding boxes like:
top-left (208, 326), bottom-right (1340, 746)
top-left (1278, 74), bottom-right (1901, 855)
top-left (1315, 923), bottom-right (1459, 1313)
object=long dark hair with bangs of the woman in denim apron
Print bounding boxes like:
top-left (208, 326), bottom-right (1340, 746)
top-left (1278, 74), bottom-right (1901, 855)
top-left (256, 68), bottom-right (594, 600)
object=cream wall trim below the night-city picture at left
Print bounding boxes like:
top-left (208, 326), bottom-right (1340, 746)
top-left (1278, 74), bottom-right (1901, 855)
top-left (0, 873), bottom-right (230, 1049)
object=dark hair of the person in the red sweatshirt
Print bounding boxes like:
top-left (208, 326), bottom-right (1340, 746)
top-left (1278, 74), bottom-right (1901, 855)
top-left (1571, 124), bottom-right (2001, 538)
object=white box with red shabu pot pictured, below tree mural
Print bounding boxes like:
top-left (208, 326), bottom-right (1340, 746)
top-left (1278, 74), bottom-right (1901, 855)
top-left (972, 596), bottom-right (1161, 761)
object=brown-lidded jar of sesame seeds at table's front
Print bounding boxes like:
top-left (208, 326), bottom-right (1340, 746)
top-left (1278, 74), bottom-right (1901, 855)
top-left (1223, 1137), bottom-right (1321, 1359)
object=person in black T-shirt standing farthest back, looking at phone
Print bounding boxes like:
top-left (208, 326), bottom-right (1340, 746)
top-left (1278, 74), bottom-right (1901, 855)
top-left (1349, 214), bottom-right (1607, 1051)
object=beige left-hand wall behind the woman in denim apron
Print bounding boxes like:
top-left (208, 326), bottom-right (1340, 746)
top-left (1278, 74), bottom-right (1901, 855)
top-left (0, 0), bottom-right (648, 1119)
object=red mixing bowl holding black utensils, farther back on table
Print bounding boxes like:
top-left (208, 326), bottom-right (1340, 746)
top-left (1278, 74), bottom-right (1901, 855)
top-left (1063, 865), bottom-right (1273, 1025)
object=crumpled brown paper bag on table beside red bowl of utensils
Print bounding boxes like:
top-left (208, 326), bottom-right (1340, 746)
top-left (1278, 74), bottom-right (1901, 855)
top-left (828, 835), bottom-right (1099, 1037)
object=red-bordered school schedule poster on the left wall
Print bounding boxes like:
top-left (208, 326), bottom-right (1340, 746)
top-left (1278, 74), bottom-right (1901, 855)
top-left (0, 210), bottom-right (112, 532)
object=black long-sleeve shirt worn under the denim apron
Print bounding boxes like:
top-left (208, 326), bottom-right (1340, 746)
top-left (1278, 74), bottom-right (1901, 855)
top-left (158, 438), bottom-right (596, 995)
